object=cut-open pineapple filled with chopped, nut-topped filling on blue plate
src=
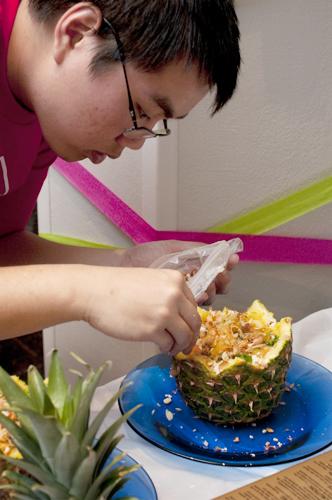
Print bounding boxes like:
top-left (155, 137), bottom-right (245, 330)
top-left (173, 300), bottom-right (292, 424)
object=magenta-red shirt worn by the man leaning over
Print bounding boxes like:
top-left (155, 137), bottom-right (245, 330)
top-left (0, 0), bottom-right (56, 236)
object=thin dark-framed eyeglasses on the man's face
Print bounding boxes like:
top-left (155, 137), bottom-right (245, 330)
top-left (101, 18), bottom-right (171, 139)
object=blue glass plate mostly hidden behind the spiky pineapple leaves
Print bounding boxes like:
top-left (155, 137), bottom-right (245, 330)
top-left (105, 448), bottom-right (158, 500)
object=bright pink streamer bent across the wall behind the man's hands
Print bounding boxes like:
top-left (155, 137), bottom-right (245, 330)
top-left (54, 158), bottom-right (332, 265)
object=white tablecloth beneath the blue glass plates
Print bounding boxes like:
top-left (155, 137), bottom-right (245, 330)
top-left (92, 308), bottom-right (332, 500)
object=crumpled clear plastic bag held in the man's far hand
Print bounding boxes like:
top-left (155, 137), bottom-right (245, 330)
top-left (151, 238), bottom-right (243, 300)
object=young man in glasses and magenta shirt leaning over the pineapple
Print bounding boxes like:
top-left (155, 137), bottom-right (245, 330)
top-left (0, 0), bottom-right (240, 353)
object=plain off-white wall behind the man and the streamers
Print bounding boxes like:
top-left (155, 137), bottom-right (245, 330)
top-left (39, 0), bottom-right (332, 376)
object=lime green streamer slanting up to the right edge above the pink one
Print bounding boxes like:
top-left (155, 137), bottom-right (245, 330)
top-left (207, 176), bottom-right (332, 234)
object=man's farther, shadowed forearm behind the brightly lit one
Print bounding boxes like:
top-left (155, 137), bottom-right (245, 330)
top-left (0, 231), bottom-right (124, 266)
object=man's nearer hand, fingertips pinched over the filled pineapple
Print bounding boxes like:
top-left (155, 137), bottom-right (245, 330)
top-left (79, 266), bottom-right (201, 355)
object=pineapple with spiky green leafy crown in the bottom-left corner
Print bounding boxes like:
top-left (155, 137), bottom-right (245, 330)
top-left (0, 350), bottom-right (139, 500)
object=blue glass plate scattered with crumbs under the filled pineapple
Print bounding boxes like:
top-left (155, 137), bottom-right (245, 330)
top-left (119, 354), bottom-right (332, 467)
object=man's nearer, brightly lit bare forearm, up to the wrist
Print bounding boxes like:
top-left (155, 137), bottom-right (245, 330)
top-left (0, 265), bottom-right (82, 339)
